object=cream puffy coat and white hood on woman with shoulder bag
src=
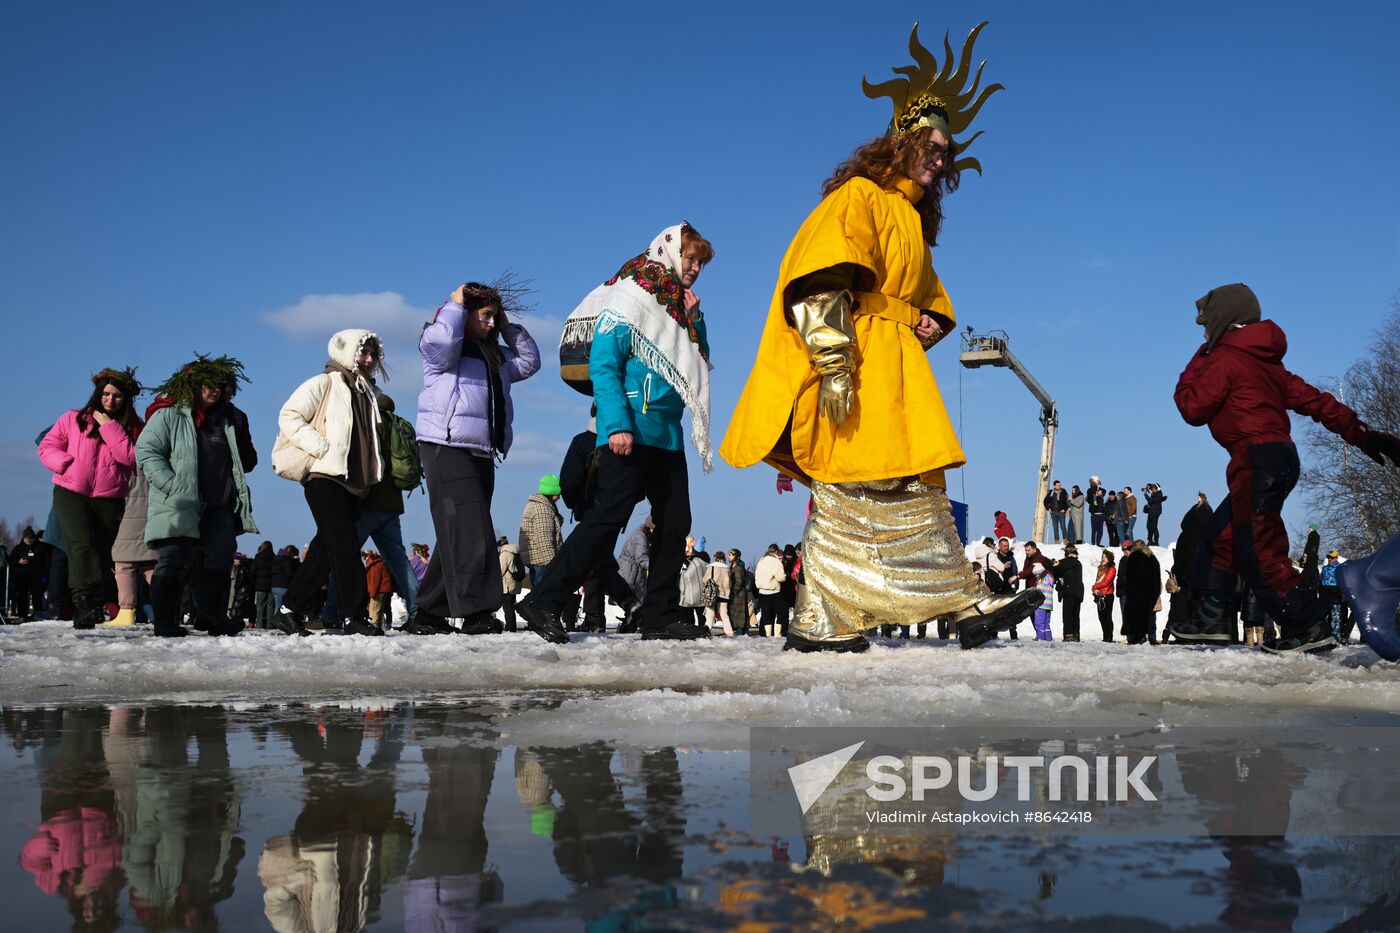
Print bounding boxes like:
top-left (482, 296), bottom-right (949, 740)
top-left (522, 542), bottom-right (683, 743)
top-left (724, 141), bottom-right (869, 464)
top-left (273, 329), bottom-right (384, 486)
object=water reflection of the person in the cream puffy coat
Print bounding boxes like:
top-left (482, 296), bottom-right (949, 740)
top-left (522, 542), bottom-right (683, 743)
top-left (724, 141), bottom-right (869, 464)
top-left (258, 710), bottom-right (412, 933)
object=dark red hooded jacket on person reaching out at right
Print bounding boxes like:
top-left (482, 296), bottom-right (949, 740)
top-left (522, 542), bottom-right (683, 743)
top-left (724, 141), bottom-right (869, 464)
top-left (1176, 321), bottom-right (1365, 450)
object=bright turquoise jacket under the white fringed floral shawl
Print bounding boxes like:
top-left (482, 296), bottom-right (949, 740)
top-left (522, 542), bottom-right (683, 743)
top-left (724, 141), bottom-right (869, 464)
top-left (588, 317), bottom-right (710, 450)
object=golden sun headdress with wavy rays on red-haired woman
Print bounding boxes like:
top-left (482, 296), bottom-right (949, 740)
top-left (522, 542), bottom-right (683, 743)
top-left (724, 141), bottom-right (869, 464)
top-left (861, 22), bottom-right (1004, 175)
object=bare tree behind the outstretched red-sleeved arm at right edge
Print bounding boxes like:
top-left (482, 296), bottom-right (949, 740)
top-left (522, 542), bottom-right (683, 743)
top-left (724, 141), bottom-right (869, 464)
top-left (1298, 293), bottom-right (1400, 556)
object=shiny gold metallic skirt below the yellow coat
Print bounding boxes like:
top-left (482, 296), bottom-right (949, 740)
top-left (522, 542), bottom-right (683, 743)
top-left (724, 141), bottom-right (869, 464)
top-left (790, 476), bottom-right (990, 642)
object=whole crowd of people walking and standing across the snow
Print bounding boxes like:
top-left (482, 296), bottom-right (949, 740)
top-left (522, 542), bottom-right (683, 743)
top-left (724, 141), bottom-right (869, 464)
top-left (2, 25), bottom-right (1400, 660)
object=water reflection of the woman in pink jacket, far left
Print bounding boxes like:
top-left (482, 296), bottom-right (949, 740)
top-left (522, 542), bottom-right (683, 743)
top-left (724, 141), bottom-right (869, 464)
top-left (20, 707), bottom-right (126, 930)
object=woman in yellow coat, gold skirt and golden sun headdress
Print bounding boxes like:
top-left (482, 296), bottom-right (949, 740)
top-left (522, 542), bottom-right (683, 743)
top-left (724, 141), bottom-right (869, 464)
top-left (720, 19), bottom-right (1040, 651)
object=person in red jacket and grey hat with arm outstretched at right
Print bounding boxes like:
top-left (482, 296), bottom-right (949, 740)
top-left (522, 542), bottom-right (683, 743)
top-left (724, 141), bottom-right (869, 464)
top-left (1172, 283), bottom-right (1400, 653)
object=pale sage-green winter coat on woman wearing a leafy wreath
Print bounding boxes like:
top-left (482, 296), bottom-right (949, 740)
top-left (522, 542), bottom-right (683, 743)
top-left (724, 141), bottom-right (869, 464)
top-left (136, 406), bottom-right (258, 546)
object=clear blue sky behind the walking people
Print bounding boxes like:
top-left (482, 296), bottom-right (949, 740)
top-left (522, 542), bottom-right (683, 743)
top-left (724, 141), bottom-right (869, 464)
top-left (0, 1), bottom-right (1400, 552)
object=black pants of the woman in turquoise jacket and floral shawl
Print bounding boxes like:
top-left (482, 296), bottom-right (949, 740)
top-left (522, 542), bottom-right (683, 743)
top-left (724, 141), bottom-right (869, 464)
top-left (529, 444), bottom-right (694, 629)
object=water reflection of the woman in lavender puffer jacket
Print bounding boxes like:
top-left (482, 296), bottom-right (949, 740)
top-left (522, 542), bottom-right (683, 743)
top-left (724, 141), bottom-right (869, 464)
top-left (403, 706), bottom-right (505, 933)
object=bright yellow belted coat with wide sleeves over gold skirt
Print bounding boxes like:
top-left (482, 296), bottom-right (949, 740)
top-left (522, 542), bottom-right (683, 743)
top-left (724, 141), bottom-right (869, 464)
top-left (720, 171), bottom-right (966, 486)
